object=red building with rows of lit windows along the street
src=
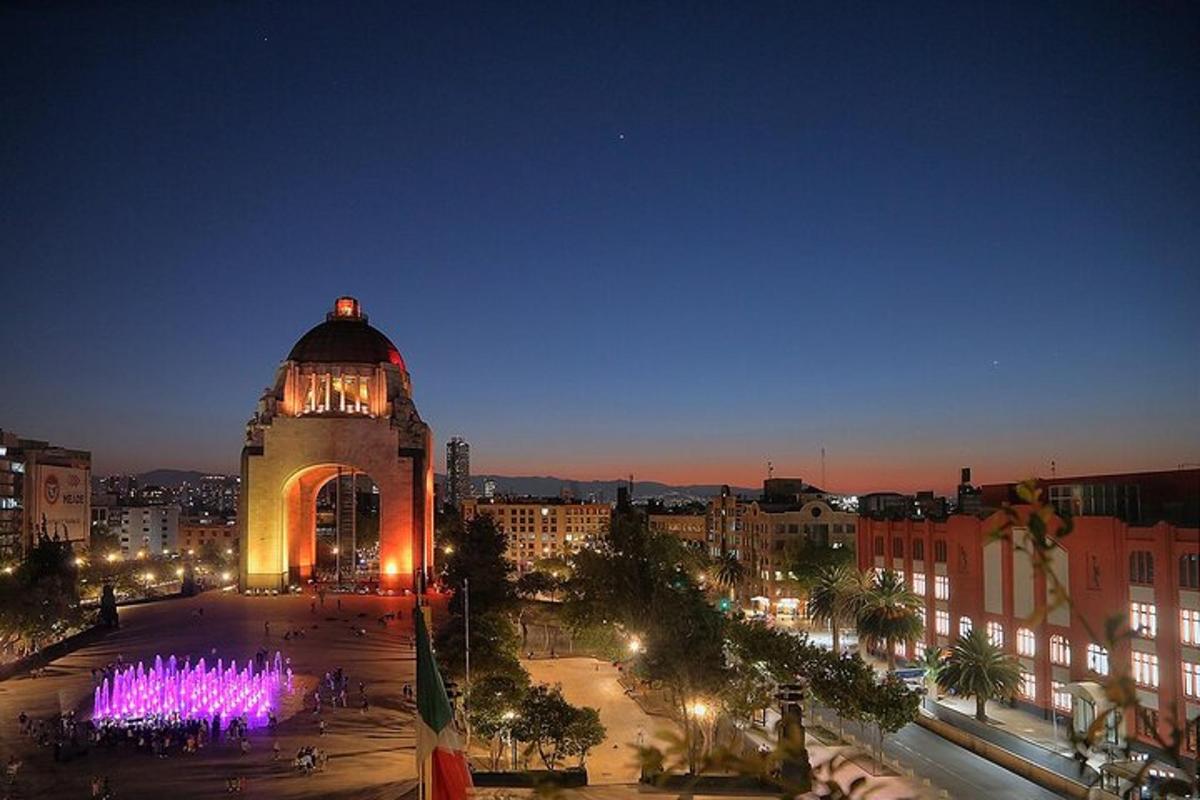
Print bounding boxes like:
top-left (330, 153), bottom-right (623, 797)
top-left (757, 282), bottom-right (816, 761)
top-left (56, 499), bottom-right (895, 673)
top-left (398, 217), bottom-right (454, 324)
top-left (858, 470), bottom-right (1200, 758)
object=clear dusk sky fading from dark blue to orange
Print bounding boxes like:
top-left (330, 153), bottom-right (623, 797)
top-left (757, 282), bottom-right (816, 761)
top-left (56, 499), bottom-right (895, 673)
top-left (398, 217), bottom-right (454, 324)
top-left (0, 0), bottom-right (1200, 492)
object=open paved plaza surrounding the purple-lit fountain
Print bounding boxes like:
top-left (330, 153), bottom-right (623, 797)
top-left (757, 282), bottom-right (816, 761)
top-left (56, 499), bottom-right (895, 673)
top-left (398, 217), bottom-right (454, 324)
top-left (0, 593), bottom-right (416, 800)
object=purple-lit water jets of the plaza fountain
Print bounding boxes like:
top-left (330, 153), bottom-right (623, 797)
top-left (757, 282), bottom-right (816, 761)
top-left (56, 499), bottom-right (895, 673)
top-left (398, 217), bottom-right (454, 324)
top-left (92, 652), bottom-right (292, 728)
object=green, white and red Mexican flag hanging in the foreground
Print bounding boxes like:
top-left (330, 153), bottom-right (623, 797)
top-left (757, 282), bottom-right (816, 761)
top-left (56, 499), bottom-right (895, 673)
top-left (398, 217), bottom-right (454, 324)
top-left (413, 608), bottom-right (470, 800)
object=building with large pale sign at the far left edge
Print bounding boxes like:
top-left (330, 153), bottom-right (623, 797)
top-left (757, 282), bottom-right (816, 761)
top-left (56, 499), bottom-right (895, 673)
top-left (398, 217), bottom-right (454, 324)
top-left (0, 429), bottom-right (91, 560)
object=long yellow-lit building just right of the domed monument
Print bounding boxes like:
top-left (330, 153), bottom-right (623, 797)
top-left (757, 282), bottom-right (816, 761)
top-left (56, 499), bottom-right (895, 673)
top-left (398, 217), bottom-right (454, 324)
top-left (462, 498), bottom-right (612, 572)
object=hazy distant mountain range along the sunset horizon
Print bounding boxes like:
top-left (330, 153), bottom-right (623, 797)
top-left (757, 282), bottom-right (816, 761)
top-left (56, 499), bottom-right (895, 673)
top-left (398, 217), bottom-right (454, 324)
top-left (108, 469), bottom-right (761, 500)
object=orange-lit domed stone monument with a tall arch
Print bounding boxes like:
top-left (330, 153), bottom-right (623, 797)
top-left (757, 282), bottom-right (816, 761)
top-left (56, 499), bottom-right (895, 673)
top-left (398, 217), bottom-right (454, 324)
top-left (238, 297), bottom-right (433, 590)
